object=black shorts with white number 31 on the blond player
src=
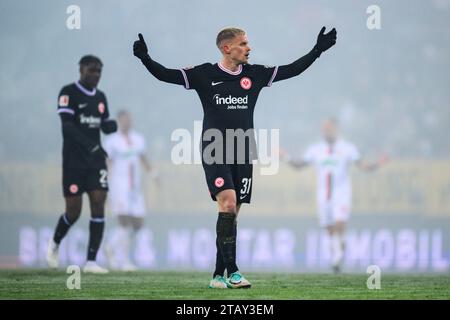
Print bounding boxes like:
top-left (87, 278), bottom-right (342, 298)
top-left (203, 163), bottom-right (253, 204)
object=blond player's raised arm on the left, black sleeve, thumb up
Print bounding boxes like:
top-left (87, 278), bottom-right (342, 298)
top-left (133, 33), bottom-right (185, 85)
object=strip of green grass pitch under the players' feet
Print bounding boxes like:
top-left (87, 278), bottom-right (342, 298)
top-left (0, 269), bottom-right (450, 300)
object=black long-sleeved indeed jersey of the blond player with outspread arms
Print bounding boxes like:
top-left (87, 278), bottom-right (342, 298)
top-left (142, 49), bottom-right (320, 162)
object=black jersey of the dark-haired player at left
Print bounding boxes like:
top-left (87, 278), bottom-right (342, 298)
top-left (57, 82), bottom-right (113, 169)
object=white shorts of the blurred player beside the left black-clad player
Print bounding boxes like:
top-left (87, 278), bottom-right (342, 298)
top-left (108, 188), bottom-right (145, 217)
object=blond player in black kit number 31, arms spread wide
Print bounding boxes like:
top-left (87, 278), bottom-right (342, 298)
top-left (133, 27), bottom-right (336, 288)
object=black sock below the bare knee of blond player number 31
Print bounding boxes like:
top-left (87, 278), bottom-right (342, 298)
top-left (216, 212), bottom-right (238, 275)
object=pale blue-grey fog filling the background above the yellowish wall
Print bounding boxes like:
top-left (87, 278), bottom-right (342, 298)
top-left (0, 0), bottom-right (450, 162)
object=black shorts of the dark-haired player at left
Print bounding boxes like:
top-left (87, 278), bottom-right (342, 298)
top-left (63, 167), bottom-right (108, 197)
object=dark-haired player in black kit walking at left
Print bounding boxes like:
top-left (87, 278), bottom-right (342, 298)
top-left (47, 55), bottom-right (117, 273)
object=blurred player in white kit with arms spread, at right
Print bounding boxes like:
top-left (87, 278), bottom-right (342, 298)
top-left (281, 118), bottom-right (388, 273)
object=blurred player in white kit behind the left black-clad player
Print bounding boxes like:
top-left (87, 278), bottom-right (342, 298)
top-left (104, 111), bottom-right (151, 271)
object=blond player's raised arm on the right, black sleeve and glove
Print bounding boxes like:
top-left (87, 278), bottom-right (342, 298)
top-left (273, 27), bottom-right (336, 82)
